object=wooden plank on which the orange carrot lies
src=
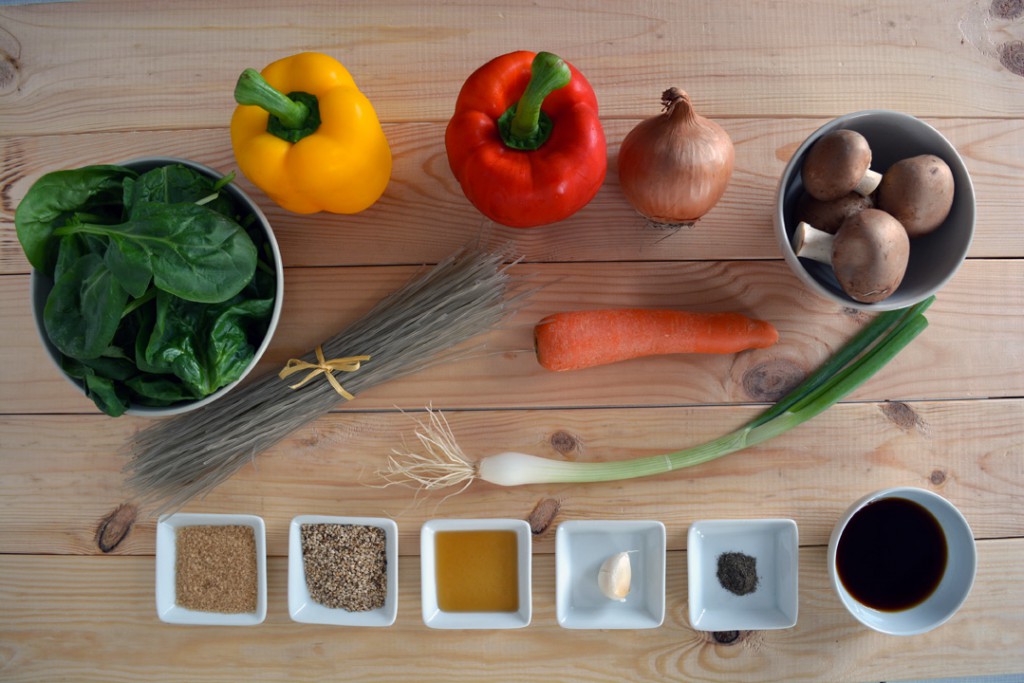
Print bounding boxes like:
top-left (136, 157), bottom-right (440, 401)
top-left (0, 260), bottom-right (1024, 414)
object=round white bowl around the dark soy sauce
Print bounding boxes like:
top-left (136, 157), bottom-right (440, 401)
top-left (828, 486), bottom-right (978, 636)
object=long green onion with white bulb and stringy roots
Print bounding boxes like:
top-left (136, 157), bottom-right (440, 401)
top-left (381, 296), bottom-right (935, 488)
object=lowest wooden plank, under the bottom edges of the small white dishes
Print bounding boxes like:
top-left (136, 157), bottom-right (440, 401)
top-left (0, 540), bottom-right (1024, 683)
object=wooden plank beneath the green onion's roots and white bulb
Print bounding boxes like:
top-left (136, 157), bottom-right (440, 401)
top-left (0, 399), bottom-right (1024, 555)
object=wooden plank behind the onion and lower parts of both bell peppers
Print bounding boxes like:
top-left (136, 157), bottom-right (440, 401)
top-left (0, 119), bottom-right (1024, 273)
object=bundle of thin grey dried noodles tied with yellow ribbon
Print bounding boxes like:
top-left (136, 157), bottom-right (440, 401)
top-left (125, 249), bottom-right (529, 514)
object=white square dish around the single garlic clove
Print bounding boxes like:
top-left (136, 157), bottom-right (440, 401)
top-left (555, 520), bottom-right (666, 629)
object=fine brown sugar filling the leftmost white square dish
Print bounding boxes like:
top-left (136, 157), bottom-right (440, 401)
top-left (174, 524), bottom-right (258, 614)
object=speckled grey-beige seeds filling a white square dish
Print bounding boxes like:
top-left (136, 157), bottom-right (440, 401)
top-left (301, 524), bottom-right (387, 612)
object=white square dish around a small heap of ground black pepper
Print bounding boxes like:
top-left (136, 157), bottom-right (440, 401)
top-left (686, 519), bottom-right (800, 631)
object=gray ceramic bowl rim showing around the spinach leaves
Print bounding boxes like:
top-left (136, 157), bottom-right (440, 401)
top-left (30, 157), bottom-right (285, 417)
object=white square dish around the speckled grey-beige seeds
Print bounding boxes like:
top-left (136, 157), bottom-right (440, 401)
top-left (288, 515), bottom-right (398, 627)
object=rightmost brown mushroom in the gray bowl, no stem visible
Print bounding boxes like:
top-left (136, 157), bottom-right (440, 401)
top-left (878, 155), bottom-right (953, 238)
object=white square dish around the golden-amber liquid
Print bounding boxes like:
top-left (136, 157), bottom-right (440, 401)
top-left (420, 519), bottom-right (534, 629)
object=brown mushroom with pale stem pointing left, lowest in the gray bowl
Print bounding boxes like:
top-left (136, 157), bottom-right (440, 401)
top-left (794, 209), bottom-right (910, 303)
